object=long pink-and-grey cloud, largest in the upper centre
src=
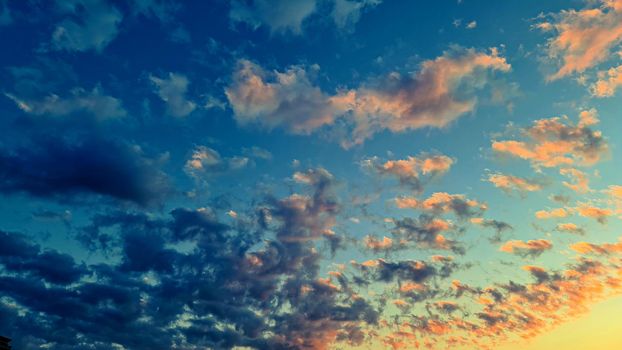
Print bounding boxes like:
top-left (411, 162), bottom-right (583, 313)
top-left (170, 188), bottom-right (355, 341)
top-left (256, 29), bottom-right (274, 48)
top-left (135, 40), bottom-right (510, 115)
top-left (225, 49), bottom-right (510, 147)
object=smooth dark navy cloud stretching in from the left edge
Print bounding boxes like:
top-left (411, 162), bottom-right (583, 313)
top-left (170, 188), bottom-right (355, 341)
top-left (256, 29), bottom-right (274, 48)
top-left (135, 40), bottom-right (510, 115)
top-left (0, 136), bottom-right (170, 205)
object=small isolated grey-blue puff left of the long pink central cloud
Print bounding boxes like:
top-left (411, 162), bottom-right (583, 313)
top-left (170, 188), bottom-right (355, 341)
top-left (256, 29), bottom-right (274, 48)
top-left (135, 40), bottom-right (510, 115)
top-left (149, 73), bottom-right (197, 117)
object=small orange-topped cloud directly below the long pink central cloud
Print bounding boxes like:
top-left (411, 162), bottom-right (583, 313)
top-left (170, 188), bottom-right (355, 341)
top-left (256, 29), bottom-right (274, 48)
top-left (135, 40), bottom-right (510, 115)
top-left (361, 154), bottom-right (454, 191)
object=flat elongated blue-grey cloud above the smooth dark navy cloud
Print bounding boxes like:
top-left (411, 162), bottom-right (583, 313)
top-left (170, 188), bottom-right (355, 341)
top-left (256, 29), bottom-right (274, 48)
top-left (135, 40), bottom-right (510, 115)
top-left (5, 87), bottom-right (127, 120)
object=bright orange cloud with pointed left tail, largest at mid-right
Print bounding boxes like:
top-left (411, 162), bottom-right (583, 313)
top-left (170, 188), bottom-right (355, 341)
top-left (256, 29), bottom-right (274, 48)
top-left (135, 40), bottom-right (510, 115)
top-left (492, 109), bottom-right (609, 168)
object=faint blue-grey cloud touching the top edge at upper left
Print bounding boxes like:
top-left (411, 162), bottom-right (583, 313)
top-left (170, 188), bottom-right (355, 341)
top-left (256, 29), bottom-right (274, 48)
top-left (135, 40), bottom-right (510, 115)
top-left (51, 0), bottom-right (123, 53)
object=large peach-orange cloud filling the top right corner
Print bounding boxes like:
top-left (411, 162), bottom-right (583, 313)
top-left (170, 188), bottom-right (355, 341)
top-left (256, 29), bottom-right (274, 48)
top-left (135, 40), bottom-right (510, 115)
top-left (537, 0), bottom-right (622, 80)
